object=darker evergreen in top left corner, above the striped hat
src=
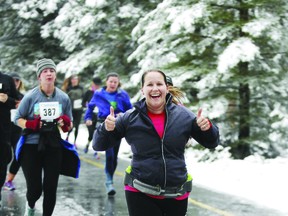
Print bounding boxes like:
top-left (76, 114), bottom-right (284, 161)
top-left (0, 0), bottom-right (65, 88)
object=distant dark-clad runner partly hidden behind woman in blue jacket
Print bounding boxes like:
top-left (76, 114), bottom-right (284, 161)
top-left (82, 77), bottom-right (102, 159)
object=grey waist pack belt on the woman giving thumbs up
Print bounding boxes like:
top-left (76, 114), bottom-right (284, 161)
top-left (124, 172), bottom-right (192, 198)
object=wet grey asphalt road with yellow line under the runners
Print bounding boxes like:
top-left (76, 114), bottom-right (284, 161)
top-left (0, 149), bottom-right (284, 216)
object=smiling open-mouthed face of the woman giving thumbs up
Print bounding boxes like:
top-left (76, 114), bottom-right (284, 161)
top-left (141, 71), bottom-right (168, 114)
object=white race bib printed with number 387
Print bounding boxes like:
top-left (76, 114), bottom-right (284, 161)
top-left (39, 102), bottom-right (60, 120)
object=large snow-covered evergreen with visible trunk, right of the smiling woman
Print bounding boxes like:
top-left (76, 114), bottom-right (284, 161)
top-left (129, 0), bottom-right (288, 158)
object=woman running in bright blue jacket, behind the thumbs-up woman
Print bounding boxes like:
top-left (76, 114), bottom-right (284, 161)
top-left (84, 73), bottom-right (132, 196)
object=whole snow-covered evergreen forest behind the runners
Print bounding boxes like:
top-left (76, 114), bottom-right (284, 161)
top-left (0, 0), bottom-right (288, 160)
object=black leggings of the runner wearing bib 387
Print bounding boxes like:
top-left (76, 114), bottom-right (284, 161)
top-left (20, 144), bottom-right (62, 216)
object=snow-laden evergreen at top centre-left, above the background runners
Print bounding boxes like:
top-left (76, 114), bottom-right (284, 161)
top-left (1, 0), bottom-right (161, 87)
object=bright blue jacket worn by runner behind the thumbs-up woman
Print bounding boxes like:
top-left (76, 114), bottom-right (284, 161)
top-left (84, 87), bottom-right (132, 121)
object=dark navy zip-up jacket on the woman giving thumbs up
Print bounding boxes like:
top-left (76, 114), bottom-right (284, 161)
top-left (93, 94), bottom-right (219, 188)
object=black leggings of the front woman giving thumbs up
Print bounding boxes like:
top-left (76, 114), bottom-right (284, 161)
top-left (125, 191), bottom-right (188, 216)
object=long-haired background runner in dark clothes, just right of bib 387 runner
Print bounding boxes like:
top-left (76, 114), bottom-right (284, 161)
top-left (62, 75), bottom-right (84, 148)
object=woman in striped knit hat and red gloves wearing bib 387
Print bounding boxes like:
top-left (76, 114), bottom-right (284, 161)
top-left (14, 59), bottom-right (73, 216)
